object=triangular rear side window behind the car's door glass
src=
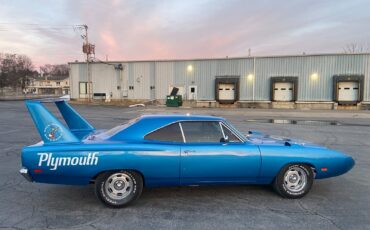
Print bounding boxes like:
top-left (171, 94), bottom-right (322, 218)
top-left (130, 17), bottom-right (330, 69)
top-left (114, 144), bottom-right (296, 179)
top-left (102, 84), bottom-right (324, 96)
top-left (144, 123), bottom-right (184, 142)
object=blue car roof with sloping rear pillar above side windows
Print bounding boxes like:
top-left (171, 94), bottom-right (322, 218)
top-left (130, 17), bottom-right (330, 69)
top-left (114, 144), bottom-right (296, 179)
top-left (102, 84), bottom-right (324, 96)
top-left (109, 114), bottom-right (225, 140)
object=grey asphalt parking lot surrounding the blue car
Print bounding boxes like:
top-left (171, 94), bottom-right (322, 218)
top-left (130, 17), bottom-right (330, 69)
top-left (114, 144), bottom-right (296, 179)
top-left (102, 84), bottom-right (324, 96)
top-left (0, 102), bottom-right (370, 229)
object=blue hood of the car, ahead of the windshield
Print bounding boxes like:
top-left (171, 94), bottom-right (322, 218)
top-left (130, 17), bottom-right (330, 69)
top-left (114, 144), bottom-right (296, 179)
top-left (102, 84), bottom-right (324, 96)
top-left (246, 131), bottom-right (325, 148)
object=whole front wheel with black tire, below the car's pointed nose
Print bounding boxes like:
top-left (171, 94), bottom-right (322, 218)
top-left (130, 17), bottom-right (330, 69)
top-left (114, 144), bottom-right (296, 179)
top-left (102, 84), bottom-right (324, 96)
top-left (272, 164), bottom-right (314, 199)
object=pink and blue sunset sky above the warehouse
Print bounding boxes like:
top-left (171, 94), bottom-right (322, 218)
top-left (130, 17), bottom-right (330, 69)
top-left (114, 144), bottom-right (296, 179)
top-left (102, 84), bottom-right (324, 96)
top-left (0, 0), bottom-right (370, 67)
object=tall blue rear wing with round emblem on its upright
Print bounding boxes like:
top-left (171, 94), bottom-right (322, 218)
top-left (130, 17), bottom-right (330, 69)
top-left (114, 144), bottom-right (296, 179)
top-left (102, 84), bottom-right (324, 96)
top-left (26, 98), bottom-right (95, 144)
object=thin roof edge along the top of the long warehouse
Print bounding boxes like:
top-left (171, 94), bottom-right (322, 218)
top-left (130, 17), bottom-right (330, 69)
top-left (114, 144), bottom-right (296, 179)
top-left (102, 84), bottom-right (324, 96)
top-left (68, 52), bottom-right (370, 64)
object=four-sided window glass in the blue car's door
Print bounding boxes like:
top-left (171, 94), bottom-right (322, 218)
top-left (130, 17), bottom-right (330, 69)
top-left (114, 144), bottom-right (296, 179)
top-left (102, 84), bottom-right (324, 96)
top-left (181, 121), bottom-right (223, 143)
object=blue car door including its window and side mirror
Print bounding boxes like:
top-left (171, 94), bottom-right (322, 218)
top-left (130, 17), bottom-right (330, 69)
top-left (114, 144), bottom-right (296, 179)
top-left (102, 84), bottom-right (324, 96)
top-left (180, 121), bottom-right (261, 184)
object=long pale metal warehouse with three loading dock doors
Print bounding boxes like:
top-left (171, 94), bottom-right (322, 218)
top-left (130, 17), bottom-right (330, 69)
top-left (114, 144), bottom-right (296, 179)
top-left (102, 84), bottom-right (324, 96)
top-left (69, 53), bottom-right (370, 109)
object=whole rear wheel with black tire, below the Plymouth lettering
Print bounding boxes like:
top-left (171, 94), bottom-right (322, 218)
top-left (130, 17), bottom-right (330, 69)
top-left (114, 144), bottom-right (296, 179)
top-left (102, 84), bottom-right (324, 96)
top-left (95, 170), bottom-right (143, 208)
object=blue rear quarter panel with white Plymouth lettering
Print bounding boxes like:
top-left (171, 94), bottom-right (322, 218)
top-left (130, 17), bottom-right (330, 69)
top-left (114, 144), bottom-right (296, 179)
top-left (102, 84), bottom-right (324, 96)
top-left (22, 144), bottom-right (180, 185)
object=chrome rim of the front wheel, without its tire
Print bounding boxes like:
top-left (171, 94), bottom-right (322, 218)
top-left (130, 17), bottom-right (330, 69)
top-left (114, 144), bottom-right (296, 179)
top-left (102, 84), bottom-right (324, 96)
top-left (284, 167), bottom-right (307, 192)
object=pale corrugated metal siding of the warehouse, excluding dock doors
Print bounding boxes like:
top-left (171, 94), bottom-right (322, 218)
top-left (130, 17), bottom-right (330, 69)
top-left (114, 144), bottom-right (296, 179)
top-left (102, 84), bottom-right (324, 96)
top-left (70, 54), bottom-right (370, 101)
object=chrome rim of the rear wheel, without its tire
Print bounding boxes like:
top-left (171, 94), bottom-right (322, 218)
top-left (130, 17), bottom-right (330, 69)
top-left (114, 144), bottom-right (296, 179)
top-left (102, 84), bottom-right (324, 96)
top-left (104, 173), bottom-right (134, 200)
